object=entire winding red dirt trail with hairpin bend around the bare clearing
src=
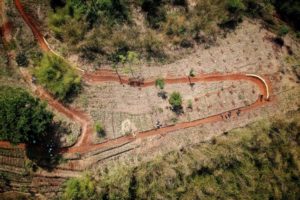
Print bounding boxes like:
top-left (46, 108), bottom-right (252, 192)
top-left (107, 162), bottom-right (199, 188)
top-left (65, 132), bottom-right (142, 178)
top-left (0, 0), bottom-right (271, 153)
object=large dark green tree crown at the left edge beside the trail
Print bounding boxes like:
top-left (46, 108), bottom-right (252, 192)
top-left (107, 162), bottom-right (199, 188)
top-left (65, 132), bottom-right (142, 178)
top-left (0, 86), bottom-right (53, 144)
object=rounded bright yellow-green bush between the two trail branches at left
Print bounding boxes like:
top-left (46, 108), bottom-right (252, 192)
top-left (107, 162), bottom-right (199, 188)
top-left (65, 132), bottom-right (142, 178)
top-left (34, 54), bottom-right (81, 101)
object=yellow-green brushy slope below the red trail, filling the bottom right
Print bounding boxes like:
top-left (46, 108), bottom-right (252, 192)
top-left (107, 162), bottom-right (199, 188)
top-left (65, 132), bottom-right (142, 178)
top-left (64, 114), bottom-right (300, 200)
